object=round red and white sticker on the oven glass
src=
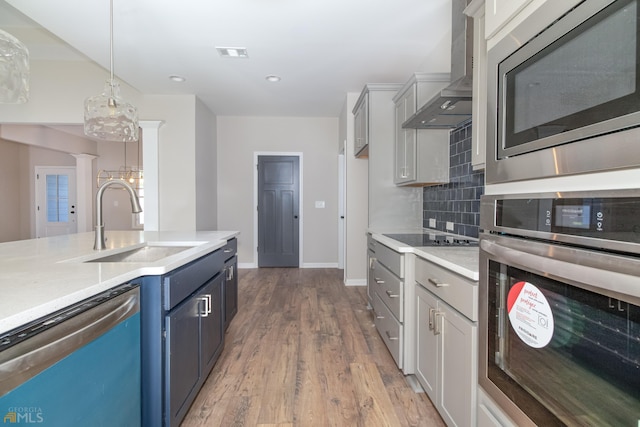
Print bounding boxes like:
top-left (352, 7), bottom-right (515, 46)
top-left (507, 282), bottom-right (553, 348)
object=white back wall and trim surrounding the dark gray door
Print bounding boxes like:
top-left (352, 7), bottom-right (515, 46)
top-left (218, 116), bottom-right (338, 267)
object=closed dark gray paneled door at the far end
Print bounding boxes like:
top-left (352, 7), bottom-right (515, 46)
top-left (258, 156), bottom-right (300, 267)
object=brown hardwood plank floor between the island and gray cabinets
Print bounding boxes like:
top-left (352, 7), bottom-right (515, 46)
top-left (182, 268), bottom-right (444, 427)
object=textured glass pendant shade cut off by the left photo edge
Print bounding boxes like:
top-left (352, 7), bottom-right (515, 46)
top-left (0, 30), bottom-right (29, 104)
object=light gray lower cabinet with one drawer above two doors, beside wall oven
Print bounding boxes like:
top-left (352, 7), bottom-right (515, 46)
top-left (416, 258), bottom-right (478, 426)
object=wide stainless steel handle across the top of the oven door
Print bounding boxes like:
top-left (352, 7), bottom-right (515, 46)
top-left (480, 237), bottom-right (640, 303)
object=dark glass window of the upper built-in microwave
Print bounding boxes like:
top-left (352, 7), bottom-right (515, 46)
top-left (503, 0), bottom-right (640, 149)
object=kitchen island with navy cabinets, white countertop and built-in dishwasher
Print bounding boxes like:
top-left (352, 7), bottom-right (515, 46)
top-left (0, 231), bottom-right (238, 426)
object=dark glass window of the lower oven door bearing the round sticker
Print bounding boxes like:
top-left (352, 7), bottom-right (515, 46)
top-left (488, 261), bottom-right (640, 427)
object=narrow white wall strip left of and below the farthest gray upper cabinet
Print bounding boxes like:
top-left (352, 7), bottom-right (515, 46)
top-left (339, 92), bottom-right (369, 285)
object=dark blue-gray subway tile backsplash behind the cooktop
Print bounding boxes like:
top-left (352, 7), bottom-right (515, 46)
top-left (422, 120), bottom-right (484, 237)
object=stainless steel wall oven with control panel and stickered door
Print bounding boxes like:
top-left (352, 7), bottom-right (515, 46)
top-left (479, 190), bottom-right (640, 427)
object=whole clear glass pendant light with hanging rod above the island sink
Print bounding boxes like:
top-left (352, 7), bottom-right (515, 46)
top-left (84, 0), bottom-right (139, 142)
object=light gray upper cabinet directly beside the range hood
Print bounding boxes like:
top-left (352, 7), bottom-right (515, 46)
top-left (393, 73), bottom-right (450, 186)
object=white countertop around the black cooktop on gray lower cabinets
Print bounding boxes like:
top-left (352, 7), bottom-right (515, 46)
top-left (369, 228), bottom-right (480, 281)
